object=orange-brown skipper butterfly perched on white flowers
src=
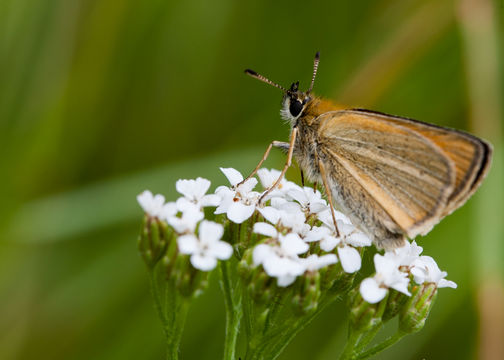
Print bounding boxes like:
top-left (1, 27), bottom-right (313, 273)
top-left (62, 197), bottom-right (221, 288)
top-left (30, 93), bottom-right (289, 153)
top-left (245, 53), bottom-right (492, 250)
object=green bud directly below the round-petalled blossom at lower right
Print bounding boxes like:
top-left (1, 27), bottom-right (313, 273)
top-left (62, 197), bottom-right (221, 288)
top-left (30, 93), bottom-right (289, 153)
top-left (350, 287), bottom-right (388, 332)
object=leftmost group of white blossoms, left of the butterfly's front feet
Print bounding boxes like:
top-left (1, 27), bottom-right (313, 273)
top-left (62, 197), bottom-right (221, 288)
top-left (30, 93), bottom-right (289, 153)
top-left (137, 178), bottom-right (233, 271)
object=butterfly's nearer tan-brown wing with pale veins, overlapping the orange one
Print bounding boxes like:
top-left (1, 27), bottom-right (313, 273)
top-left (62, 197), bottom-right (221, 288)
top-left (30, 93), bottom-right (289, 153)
top-left (318, 110), bottom-right (455, 238)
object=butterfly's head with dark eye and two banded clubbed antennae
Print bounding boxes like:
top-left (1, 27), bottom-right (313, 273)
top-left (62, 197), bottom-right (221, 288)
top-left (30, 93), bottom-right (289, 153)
top-left (245, 52), bottom-right (320, 126)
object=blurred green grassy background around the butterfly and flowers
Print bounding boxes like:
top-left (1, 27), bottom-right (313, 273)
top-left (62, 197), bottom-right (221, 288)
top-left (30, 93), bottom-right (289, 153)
top-left (0, 0), bottom-right (504, 360)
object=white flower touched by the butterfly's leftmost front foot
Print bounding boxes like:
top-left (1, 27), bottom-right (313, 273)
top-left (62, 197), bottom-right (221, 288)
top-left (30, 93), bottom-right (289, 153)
top-left (214, 168), bottom-right (260, 224)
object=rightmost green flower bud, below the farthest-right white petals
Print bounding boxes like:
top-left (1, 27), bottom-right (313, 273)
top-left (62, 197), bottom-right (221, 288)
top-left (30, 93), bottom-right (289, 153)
top-left (399, 283), bottom-right (437, 334)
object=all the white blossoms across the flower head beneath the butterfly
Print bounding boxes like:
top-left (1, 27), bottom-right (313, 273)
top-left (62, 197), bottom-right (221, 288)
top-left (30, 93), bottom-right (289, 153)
top-left (137, 168), bottom-right (456, 303)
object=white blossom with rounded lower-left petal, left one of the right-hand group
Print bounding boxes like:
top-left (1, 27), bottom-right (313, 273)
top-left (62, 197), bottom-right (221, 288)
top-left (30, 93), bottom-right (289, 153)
top-left (359, 254), bottom-right (411, 304)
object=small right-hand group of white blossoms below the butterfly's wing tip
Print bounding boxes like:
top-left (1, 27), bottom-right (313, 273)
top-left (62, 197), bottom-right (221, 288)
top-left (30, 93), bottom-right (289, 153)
top-left (360, 241), bottom-right (457, 304)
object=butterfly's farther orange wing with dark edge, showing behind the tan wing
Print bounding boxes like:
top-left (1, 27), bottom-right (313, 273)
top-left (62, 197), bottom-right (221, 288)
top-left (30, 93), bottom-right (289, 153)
top-left (352, 110), bottom-right (492, 216)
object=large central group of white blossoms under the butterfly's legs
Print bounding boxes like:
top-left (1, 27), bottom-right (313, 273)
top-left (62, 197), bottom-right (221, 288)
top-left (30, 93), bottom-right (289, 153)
top-left (215, 169), bottom-right (371, 287)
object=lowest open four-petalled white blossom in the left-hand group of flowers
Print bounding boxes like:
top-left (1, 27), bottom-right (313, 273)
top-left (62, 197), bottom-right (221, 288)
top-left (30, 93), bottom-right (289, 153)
top-left (177, 220), bottom-right (233, 271)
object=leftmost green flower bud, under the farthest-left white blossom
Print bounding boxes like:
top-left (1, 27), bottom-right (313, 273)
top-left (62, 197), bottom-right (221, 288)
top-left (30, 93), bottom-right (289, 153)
top-left (138, 214), bottom-right (172, 268)
